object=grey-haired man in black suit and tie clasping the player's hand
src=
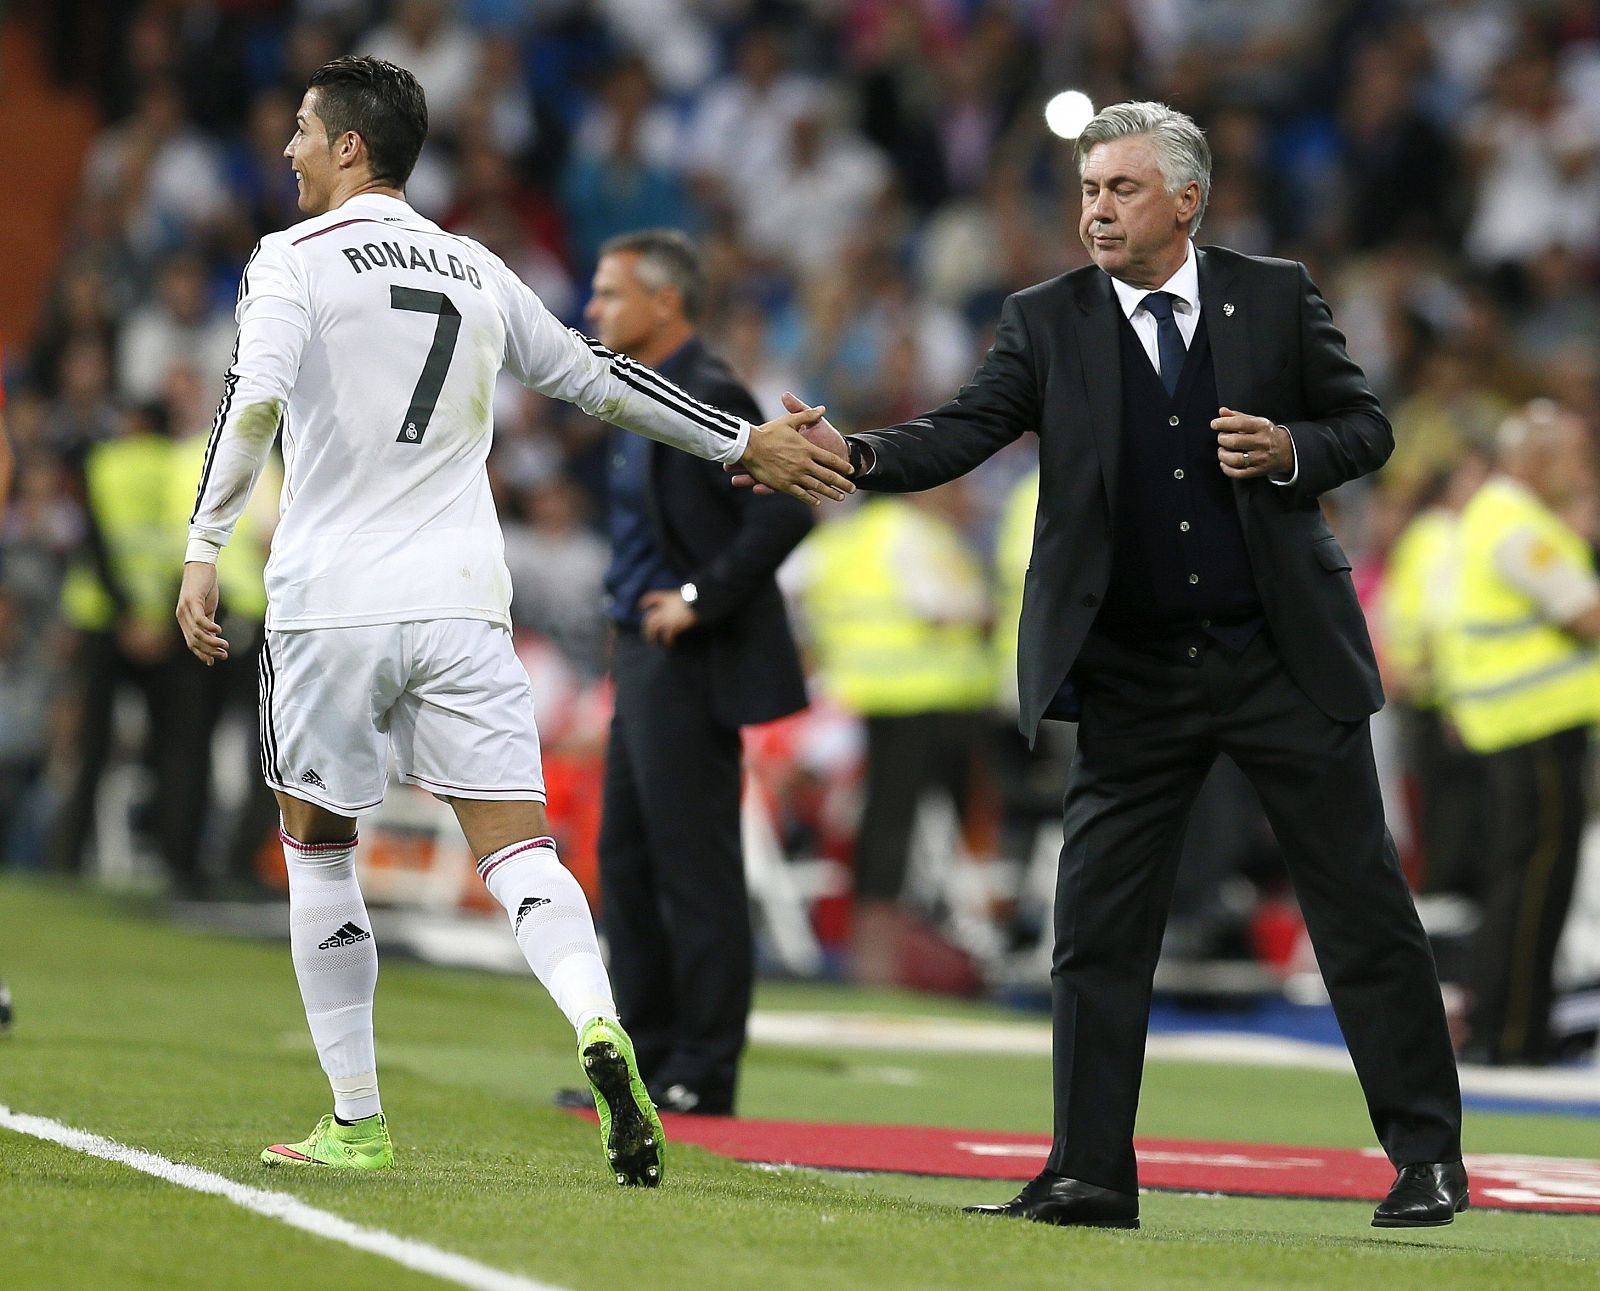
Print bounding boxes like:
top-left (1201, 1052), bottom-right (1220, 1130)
top-left (768, 104), bottom-right (1467, 1227)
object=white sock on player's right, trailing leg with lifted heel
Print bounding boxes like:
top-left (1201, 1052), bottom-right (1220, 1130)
top-left (478, 838), bottom-right (616, 1032)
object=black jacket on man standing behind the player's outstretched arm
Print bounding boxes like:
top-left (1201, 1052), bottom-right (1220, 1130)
top-left (645, 338), bottom-right (811, 726)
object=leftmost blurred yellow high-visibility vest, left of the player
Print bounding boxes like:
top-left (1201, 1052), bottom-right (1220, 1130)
top-left (61, 435), bottom-right (187, 632)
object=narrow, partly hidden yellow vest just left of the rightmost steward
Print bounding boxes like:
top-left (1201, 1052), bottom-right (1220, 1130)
top-left (1378, 509), bottom-right (1459, 709)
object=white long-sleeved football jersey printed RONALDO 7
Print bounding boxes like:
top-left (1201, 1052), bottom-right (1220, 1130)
top-left (189, 194), bottom-right (750, 630)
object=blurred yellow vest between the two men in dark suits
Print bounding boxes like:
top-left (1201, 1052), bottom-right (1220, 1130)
top-left (803, 498), bottom-right (995, 717)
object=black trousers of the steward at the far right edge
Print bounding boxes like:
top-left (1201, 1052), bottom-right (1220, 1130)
top-left (1472, 728), bottom-right (1589, 1064)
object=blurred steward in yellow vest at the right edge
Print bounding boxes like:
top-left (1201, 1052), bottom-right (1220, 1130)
top-left (1440, 400), bottom-right (1600, 1062)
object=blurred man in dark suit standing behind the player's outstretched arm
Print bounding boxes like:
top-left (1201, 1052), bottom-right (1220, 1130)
top-left (587, 230), bottom-right (811, 1115)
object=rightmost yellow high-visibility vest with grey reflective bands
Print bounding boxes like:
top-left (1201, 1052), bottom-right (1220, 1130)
top-left (1440, 477), bottom-right (1600, 753)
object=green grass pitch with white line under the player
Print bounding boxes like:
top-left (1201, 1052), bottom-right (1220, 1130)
top-left (0, 878), bottom-right (1600, 1291)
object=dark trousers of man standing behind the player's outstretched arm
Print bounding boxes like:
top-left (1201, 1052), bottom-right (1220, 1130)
top-left (600, 632), bottom-right (754, 1112)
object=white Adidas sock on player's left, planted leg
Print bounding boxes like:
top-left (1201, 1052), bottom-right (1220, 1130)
top-left (278, 830), bottom-right (382, 1121)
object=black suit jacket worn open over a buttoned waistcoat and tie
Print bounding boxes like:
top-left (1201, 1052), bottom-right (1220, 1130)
top-left (851, 246), bottom-right (1394, 739)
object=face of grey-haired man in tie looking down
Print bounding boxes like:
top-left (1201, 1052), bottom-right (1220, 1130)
top-left (1078, 134), bottom-right (1200, 288)
